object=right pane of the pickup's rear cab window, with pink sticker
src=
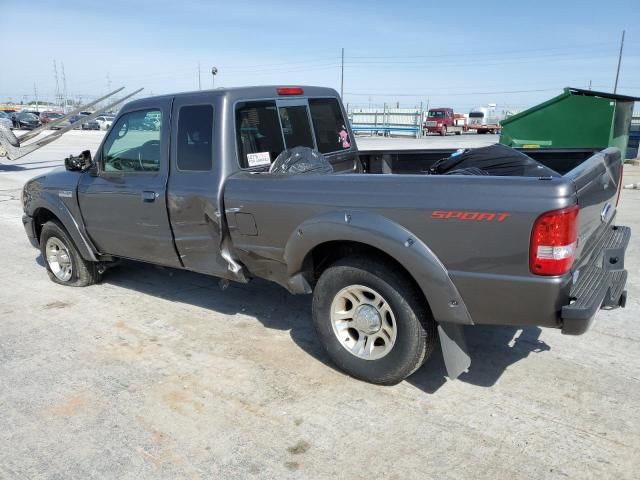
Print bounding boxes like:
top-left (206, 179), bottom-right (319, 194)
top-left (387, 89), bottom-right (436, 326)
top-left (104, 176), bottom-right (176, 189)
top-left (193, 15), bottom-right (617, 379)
top-left (309, 98), bottom-right (351, 153)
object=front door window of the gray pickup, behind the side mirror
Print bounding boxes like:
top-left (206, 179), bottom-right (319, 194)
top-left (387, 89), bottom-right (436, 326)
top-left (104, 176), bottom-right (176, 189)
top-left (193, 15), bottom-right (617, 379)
top-left (102, 110), bottom-right (162, 173)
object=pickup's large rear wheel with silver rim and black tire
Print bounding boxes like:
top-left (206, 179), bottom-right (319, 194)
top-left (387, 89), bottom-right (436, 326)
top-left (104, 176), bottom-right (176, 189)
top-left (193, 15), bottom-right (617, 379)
top-left (313, 257), bottom-right (436, 385)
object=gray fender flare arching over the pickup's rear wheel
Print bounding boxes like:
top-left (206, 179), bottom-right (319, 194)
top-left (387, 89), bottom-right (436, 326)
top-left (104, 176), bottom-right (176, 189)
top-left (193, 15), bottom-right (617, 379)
top-left (284, 211), bottom-right (473, 325)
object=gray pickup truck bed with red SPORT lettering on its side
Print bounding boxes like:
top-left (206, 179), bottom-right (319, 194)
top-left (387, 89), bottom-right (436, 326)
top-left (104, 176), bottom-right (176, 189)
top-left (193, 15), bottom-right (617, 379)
top-left (225, 149), bottom-right (622, 334)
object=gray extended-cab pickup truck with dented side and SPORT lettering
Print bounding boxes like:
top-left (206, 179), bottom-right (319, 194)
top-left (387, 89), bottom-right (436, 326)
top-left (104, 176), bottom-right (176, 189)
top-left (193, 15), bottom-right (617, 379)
top-left (16, 87), bottom-right (630, 384)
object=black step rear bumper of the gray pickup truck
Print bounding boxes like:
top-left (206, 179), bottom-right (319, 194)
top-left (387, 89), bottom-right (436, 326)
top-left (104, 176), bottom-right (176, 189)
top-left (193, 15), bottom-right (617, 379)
top-left (560, 226), bottom-right (631, 335)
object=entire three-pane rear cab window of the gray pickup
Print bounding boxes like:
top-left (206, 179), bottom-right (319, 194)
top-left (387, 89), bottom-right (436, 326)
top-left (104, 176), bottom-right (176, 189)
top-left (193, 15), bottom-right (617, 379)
top-left (235, 98), bottom-right (351, 171)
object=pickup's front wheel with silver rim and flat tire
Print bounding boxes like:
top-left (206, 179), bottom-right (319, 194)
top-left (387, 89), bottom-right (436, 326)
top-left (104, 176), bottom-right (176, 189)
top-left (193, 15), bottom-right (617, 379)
top-left (40, 221), bottom-right (99, 287)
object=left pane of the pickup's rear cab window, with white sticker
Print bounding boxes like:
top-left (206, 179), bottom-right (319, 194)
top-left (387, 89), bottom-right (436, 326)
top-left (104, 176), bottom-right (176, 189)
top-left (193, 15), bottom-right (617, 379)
top-left (236, 100), bottom-right (284, 168)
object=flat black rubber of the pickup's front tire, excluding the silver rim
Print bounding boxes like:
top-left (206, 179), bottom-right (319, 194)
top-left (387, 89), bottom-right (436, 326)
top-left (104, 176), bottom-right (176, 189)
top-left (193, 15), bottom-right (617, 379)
top-left (40, 221), bottom-right (100, 287)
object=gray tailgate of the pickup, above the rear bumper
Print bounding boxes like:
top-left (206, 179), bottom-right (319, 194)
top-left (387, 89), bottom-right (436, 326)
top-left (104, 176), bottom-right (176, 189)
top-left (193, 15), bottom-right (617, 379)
top-left (565, 148), bottom-right (622, 267)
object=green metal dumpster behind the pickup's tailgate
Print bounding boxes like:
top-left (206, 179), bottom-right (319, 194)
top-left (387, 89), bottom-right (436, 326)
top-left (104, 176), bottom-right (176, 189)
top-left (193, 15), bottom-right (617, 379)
top-left (500, 87), bottom-right (640, 152)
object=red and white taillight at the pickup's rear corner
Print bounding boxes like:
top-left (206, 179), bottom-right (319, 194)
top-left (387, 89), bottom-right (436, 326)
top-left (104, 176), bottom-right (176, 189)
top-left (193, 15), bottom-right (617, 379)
top-left (529, 205), bottom-right (579, 275)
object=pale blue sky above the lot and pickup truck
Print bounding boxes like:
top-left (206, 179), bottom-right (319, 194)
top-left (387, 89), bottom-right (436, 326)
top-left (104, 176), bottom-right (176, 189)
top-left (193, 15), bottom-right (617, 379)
top-left (0, 0), bottom-right (640, 110)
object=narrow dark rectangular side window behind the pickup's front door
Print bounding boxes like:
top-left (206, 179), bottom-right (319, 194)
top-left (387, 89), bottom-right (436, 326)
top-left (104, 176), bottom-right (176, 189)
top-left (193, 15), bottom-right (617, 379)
top-left (178, 105), bottom-right (213, 172)
